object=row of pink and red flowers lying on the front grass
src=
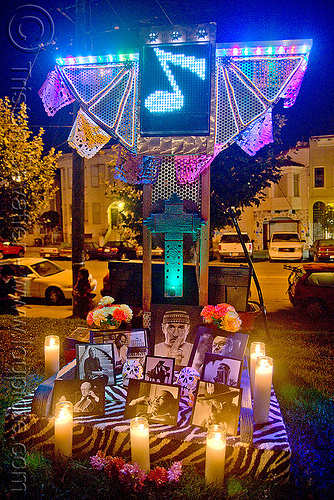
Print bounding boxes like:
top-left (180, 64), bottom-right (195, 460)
top-left (90, 450), bottom-right (182, 491)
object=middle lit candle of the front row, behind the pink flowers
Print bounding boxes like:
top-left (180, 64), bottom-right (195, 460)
top-left (130, 417), bottom-right (150, 472)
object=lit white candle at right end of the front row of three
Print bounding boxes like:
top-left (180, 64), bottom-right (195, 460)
top-left (205, 424), bottom-right (226, 486)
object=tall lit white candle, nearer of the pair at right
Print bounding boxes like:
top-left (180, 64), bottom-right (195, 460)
top-left (253, 356), bottom-right (273, 424)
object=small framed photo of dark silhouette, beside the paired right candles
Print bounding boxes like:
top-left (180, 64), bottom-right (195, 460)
top-left (201, 352), bottom-right (243, 387)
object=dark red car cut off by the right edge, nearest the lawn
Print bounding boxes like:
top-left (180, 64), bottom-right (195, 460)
top-left (284, 263), bottom-right (334, 318)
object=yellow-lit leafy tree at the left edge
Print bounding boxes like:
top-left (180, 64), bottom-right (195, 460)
top-left (0, 97), bottom-right (61, 241)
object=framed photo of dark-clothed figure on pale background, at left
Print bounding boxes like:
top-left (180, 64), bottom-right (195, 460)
top-left (76, 344), bottom-right (115, 385)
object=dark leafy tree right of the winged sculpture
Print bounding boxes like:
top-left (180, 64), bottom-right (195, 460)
top-left (211, 115), bottom-right (297, 230)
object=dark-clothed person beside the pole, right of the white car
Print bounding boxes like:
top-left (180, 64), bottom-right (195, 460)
top-left (72, 267), bottom-right (96, 319)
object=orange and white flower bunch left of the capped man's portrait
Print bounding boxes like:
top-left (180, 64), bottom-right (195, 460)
top-left (87, 296), bottom-right (132, 328)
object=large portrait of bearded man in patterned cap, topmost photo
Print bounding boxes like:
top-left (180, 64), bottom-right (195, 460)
top-left (150, 304), bottom-right (203, 368)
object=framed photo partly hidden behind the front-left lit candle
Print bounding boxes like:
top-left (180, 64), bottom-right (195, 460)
top-left (52, 379), bottom-right (105, 416)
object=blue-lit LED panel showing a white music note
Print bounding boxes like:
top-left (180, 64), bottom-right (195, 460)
top-left (140, 43), bottom-right (211, 137)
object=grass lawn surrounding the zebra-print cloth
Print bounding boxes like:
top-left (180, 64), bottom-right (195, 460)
top-left (0, 316), bottom-right (334, 500)
